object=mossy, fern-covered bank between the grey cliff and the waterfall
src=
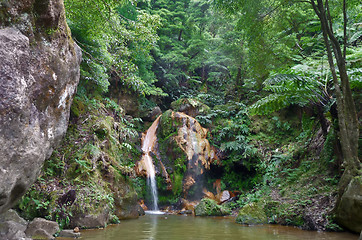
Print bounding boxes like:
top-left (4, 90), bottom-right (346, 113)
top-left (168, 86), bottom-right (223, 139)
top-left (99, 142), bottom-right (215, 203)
top-left (18, 91), bottom-right (144, 228)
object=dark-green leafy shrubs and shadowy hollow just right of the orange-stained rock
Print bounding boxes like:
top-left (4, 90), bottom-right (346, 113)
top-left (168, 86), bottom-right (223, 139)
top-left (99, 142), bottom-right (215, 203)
top-left (201, 102), bottom-right (259, 189)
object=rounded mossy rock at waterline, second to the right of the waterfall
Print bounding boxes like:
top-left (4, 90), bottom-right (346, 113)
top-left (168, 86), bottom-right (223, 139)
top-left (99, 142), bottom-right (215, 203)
top-left (236, 203), bottom-right (268, 225)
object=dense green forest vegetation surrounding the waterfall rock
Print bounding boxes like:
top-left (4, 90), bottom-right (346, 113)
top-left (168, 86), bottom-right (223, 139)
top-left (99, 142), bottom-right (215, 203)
top-left (18, 0), bottom-right (362, 230)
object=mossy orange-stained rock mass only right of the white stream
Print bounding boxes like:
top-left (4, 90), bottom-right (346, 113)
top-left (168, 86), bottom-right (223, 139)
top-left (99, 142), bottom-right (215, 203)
top-left (157, 110), bottom-right (218, 199)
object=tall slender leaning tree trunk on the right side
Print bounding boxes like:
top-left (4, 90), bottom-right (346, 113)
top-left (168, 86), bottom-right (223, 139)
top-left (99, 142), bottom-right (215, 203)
top-left (311, 0), bottom-right (361, 195)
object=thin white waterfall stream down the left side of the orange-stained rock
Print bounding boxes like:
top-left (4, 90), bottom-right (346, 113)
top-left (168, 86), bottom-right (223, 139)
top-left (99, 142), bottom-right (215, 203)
top-left (142, 117), bottom-right (160, 211)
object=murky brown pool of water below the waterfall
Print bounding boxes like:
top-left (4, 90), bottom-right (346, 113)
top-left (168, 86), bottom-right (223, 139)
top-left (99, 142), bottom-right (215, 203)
top-left (76, 215), bottom-right (358, 240)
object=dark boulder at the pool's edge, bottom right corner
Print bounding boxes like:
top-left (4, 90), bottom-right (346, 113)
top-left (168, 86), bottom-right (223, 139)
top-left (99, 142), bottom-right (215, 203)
top-left (336, 176), bottom-right (362, 233)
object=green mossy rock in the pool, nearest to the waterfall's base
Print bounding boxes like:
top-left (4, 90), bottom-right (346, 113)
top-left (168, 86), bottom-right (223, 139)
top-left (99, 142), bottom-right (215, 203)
top-left (195, 198), bottom-right (231, 216)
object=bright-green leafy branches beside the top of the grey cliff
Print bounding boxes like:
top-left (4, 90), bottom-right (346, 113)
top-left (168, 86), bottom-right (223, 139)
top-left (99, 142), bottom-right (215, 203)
top-left (65, 0), bottom-right (163, 95)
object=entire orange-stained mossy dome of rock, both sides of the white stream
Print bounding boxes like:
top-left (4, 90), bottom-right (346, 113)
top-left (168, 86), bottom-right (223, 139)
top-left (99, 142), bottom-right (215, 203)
top-left (135, 110), bottom-right (220, 205)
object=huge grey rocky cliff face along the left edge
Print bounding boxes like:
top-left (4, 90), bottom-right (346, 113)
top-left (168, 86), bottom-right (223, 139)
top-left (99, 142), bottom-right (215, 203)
top-left (0, 0), bottom-right (81, 213)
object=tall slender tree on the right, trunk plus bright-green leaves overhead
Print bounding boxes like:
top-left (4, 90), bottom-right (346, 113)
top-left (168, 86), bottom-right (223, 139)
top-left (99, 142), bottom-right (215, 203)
top-left (214, 0), bottom-right (361, 201)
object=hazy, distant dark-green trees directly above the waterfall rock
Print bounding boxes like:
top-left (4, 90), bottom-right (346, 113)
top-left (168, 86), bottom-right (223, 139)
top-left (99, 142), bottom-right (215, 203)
top-left (148, 0), bottom-right (245, 103)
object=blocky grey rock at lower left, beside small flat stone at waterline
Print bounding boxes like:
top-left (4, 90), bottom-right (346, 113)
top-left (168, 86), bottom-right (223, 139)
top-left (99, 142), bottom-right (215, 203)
top-left (25, 218), bottom-right (59, 239)
